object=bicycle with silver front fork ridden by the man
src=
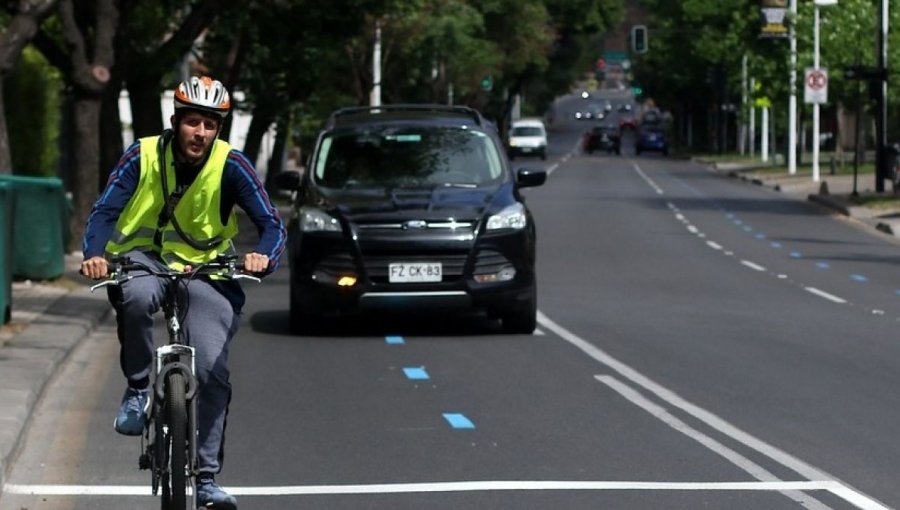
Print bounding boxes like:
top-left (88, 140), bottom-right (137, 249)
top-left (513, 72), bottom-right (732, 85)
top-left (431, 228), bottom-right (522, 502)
top-left (91, 256), bottom-right (261, 510)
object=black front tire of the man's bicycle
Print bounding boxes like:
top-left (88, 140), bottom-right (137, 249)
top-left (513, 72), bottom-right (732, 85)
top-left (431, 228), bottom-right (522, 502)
top-left (163, 371), bottom-right (188, 510)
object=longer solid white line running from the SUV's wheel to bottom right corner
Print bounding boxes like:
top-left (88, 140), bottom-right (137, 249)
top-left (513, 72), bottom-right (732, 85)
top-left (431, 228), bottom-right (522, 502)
top-left (538, 310), bottom-right (887, 510)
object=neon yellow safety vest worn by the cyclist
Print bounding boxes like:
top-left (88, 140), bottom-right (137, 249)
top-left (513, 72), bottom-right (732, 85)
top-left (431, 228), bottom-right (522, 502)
top-left (106, 136), bottom-right (238, 271)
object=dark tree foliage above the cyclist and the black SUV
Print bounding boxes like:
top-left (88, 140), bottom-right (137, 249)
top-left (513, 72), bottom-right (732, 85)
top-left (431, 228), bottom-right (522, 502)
top-left (0, 0), bottom-right (623, 251)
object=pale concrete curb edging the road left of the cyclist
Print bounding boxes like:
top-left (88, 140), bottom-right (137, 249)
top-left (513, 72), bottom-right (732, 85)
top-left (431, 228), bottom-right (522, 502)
top-left (0, 278), bottom-right (112, 492)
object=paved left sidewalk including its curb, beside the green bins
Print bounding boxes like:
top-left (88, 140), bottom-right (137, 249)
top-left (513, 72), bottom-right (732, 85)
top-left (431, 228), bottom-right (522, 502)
top-left (0, 254), bottom-right (110, 492)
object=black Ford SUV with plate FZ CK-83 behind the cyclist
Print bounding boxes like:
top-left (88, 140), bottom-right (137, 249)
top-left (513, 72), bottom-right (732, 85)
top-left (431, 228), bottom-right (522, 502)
top-left (276, 105), bottom-right (547, 333)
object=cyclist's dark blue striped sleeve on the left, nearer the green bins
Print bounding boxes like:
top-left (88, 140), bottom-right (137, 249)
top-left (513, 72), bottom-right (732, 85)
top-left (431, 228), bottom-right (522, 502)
top-left (82, 142), bottom-right (141, 259)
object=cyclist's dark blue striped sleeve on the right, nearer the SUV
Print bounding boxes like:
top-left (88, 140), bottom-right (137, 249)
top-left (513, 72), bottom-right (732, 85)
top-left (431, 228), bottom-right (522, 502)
top-left (223, 149), bottom-right (287, 274)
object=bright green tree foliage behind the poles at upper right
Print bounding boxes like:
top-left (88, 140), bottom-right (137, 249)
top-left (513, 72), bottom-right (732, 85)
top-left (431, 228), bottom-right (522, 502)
top-left (635, 0), bottom-right (900, 151)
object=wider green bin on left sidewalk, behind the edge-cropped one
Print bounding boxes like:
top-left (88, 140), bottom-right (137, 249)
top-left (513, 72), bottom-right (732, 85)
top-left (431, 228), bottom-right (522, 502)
top-left (0, 175), bottom-right (69, 280)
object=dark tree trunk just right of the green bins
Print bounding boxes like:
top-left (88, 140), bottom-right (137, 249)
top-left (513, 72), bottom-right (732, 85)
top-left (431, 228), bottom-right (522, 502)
top-left (68, 91), bottom-right (101, 251)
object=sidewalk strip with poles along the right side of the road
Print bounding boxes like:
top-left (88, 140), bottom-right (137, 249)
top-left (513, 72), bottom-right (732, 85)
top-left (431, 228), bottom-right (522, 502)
top-left (695, 158), bottom-right (900, 237)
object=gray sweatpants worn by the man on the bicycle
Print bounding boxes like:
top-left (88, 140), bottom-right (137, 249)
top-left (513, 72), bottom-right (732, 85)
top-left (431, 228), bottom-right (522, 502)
top-left (108, 251), bottom-right (240, 473)
